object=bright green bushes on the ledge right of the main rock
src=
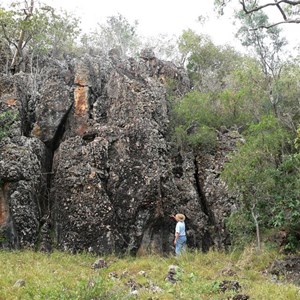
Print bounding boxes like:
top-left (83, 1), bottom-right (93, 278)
top-left (172, 72), bottom-right (263, 152)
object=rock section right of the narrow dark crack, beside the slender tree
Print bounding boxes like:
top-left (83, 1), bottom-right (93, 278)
top-left (196, 128), bottom-right (243, 249)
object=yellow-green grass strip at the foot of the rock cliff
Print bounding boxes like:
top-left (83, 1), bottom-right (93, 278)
top-left (0, 248), bottom-right (300, 300)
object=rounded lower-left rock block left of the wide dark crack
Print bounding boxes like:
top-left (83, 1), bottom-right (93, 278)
top-left (0, 136), bottom-right (46, 247)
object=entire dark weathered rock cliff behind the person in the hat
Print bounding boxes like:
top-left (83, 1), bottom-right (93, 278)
top-left (0, 51), bottom-right (239, 253)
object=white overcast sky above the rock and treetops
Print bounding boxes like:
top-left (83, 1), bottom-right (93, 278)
top-left (0, 0), bottom-right (300, 50)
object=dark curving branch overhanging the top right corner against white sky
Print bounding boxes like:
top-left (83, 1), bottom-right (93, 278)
top-left (215, 0), bottom-right (300, 29)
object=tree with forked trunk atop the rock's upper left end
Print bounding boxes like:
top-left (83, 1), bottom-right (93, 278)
top-left (0, 0), bottom-right (79, 72)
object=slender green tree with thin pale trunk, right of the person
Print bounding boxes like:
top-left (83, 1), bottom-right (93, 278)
top-left (222, 115), bottom-right (289, 247)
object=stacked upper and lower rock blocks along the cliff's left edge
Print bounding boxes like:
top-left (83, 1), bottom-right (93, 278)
top-left (0, 76), bottom-right (47, 247)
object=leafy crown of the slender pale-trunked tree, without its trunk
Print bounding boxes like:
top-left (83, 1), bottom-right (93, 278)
top-left (222, 115), bottom-right (289, 195)
